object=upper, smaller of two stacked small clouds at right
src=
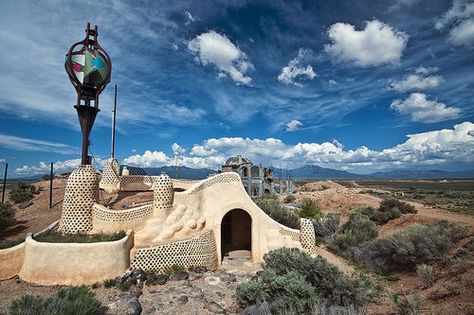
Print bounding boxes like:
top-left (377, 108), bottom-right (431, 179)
top-left (390, 67), bottom-right (444, 92)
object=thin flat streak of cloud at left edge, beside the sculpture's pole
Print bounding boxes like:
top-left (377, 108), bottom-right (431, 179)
top-left (0, 134), bottom-right (78, 154)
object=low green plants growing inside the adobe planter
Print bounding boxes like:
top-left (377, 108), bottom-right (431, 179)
top-left (33, 230), bottom-right (126, 243)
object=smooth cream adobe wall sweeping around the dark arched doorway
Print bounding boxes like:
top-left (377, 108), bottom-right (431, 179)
top-left (175, 172), bottom-right (302, 264)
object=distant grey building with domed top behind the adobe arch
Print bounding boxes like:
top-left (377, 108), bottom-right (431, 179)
top-left (220, 155), bottom-right (293, 197)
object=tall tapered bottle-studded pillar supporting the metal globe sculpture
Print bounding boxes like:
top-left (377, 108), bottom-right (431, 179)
top-left (59, 165), bottom-right (99, 234)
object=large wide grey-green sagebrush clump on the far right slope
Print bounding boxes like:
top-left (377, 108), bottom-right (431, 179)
top-left (351, 221), bottom-right (466, 272)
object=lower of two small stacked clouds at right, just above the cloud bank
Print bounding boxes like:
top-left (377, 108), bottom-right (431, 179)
top-left (390, 93), bottom-right (461, 123)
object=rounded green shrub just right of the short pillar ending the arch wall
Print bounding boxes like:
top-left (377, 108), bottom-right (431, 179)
top-left (326, 212), bottom-right (378, 254)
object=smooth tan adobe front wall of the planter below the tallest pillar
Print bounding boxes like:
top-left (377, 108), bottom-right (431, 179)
top-left (19, 230), bottom-right (133, 285)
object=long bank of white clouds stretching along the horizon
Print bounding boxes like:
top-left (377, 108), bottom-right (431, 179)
top-left (17, 122), bottom-right (474, 174)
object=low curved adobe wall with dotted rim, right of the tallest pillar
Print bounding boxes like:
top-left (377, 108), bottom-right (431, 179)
top-left (92, 203), bottom-right (153, 233)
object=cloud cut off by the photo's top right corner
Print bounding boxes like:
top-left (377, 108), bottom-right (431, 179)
top-left (435, 0), bottom-right (474, 48)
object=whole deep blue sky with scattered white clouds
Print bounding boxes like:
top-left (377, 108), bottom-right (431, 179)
top-left (0, 0), bottom-right (474, 175)
